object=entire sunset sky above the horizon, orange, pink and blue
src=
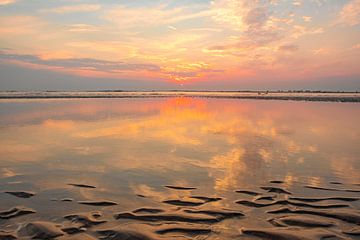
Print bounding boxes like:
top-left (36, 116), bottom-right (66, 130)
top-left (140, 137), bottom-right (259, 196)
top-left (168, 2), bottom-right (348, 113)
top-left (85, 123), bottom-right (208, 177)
top-left (0, 0), bottom-right (360, 91)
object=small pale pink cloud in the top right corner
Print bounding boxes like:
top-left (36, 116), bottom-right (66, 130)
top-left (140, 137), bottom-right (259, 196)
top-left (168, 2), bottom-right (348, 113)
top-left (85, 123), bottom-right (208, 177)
top-left (338, 0), bottom-right (360, 26)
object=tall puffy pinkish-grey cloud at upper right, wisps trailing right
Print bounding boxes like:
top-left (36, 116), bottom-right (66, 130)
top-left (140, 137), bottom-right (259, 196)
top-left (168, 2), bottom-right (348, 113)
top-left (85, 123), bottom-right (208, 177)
top-left (205, 0), bottom-right (324, 58)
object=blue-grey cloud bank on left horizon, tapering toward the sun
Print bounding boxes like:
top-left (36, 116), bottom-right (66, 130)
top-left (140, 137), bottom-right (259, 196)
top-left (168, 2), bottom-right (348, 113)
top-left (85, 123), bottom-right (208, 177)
top-left (0, 61), bottom-right (174, 91)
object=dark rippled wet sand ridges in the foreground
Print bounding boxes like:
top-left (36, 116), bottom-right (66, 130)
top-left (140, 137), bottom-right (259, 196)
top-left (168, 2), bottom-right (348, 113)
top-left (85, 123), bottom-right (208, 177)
top-left (0, 182), bottom-right (360, 240)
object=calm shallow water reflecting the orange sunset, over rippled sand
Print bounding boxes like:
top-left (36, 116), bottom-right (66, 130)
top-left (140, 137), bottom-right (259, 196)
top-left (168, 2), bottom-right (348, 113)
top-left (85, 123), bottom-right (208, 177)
top-left (0, 97), bottom-right (360, 239)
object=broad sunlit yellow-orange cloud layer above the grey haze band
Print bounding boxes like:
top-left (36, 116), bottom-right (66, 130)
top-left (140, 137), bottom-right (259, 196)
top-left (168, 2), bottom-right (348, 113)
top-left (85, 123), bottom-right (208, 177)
top-left (0, 0), bottom-right (359, 88)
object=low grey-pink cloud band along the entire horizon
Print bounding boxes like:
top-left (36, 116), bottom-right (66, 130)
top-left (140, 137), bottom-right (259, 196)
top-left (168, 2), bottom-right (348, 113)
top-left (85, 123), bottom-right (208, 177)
top-left (0, 61), bottom-right (360, 91)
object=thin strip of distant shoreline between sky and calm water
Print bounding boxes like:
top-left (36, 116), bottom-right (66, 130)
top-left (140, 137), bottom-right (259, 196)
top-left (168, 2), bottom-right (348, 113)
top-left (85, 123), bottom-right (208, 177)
top-left (0, 91), bottom-right (360, 102)
